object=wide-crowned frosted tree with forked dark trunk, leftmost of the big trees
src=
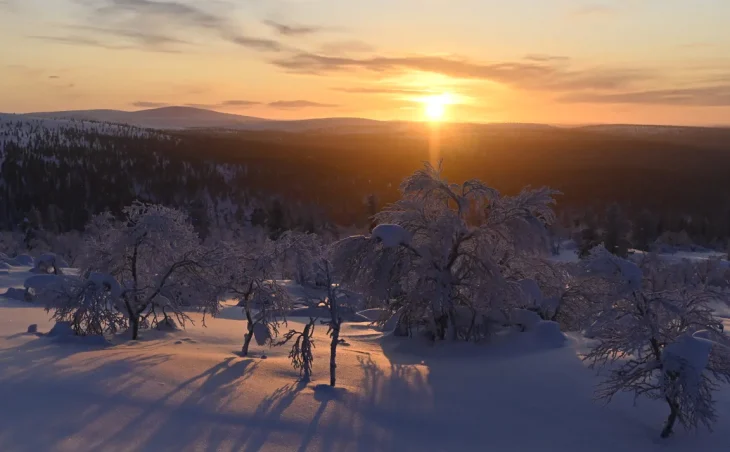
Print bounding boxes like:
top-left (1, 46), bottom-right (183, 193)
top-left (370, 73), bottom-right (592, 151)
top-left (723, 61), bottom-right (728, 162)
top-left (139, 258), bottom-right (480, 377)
top-left (85, 203), bottom-right (224, 339)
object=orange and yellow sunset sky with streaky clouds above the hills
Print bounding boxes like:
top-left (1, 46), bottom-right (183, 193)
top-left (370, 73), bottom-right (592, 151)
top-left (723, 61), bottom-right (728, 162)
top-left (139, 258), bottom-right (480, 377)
top-left (0, 0), bottom-right (730, 125)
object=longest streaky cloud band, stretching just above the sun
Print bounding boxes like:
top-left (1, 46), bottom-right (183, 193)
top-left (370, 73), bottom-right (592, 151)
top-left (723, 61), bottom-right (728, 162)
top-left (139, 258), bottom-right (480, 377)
top-left (272, 53), bottom-right (654, 91)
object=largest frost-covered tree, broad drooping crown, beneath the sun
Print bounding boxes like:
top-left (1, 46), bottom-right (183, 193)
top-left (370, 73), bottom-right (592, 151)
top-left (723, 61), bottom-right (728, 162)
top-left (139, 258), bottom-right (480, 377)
top-left (335, 164), bottom-right (555, 340)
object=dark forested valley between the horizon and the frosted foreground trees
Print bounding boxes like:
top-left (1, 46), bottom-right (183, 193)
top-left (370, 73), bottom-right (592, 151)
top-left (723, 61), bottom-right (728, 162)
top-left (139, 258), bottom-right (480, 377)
top-left (0, 118), bottom-right (730, 247)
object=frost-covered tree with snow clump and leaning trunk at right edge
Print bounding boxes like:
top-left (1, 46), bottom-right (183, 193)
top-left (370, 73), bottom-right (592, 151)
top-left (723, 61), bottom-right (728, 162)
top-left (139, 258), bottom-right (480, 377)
top-left (584, 250), bottom-right (730, 438)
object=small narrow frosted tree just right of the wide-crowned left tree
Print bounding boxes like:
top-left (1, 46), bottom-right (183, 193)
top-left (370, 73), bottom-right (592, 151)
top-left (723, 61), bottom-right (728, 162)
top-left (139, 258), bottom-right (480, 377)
top-left (226, 238), bottom-right (291, 356)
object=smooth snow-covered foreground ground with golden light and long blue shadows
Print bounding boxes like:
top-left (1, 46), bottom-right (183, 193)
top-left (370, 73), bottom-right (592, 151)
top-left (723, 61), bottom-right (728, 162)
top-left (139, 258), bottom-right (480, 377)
top-left (0, 268), bottom-right (730, 452)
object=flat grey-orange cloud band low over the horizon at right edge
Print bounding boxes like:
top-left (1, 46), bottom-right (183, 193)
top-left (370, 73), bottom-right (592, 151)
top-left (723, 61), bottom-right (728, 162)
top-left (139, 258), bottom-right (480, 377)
top-left (560, 85), bottom-right (730, 107)
